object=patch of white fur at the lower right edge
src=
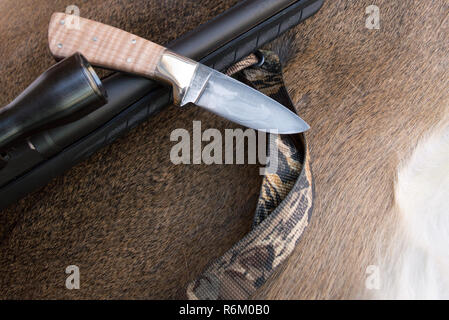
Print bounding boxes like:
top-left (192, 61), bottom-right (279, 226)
top-left (371, 124), bottom-right (449, 299)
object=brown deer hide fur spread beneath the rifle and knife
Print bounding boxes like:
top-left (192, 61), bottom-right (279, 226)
top-left (0, 0), bottom-right (449, 299)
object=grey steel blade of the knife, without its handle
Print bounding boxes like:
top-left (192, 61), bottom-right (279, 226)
top-left (181, 64), bottom-right (310, 134)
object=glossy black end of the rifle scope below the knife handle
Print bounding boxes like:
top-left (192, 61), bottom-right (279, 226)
top-left (0, 53), bottom-right (107, 150)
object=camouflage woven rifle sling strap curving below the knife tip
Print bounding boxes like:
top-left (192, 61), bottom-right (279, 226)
top-left (187, 51), bottom-right (314, 300)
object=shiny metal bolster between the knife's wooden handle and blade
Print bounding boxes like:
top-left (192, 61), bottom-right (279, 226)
top-left (155, 50), bottom-right (199, 106)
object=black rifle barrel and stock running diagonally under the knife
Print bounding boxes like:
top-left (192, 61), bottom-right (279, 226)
top-left (0, 0), bottom-right (324, 210)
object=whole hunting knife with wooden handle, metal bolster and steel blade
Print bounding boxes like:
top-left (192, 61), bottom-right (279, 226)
top-left (48, 12), bottom-right (309, 134)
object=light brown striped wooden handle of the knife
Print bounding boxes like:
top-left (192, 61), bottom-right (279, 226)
top-left (48, 12), bottom-right (166, 78)
